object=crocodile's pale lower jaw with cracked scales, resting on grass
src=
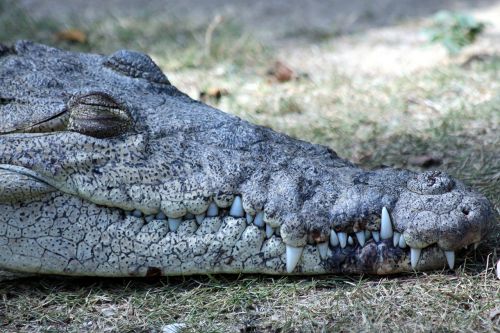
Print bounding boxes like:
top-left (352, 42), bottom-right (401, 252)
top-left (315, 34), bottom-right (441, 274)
top-left (0, 193), bottom-right (454, 277)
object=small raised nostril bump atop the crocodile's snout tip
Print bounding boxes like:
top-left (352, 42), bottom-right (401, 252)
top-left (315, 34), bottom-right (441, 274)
top-left (407, 171), bottom-right (455, 194)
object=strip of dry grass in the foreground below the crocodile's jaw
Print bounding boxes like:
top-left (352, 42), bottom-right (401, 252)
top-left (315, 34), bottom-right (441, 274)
top-left (0, 269), bottom-right (500, 332)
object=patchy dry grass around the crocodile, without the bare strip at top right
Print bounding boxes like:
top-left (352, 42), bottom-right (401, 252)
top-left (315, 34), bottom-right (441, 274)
top-left (0, 0), bottom-right (500, 332)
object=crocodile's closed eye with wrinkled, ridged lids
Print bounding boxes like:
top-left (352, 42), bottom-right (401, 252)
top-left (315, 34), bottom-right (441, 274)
top-left (67, 92), bottom-right (132, 138)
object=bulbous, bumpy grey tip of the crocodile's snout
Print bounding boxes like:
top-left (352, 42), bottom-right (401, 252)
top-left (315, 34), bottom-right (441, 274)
top-left (392, 171), bottom-right (493, 266)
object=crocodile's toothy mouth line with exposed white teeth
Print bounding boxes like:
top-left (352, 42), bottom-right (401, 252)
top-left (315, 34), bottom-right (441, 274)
top-left (119, 202), bottom-right (461, 275)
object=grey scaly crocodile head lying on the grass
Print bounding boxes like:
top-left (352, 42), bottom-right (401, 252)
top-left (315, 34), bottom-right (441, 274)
top-left (0, 41), bottom-right (496, 277)
